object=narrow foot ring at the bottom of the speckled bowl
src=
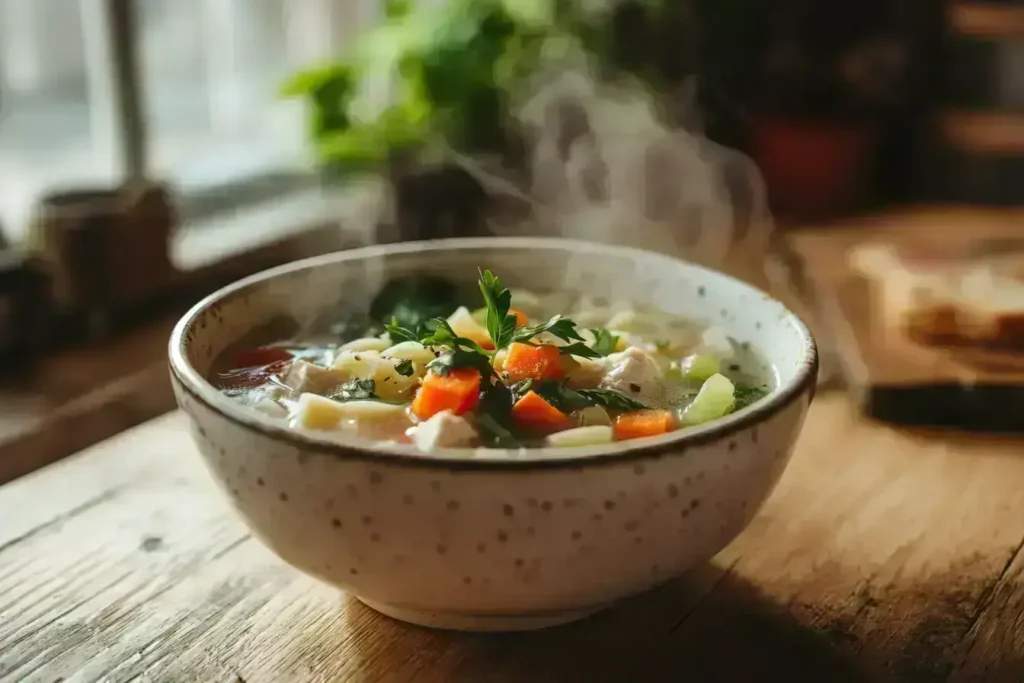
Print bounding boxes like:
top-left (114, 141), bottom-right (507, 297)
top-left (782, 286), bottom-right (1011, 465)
top-left (357, 598), bottom-right (608, 633)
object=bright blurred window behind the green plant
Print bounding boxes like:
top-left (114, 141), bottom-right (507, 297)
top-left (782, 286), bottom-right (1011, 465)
top-left (0, 0), bottom-right (377, 241)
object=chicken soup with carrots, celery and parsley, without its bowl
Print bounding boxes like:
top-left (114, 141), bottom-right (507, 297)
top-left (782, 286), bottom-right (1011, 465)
top-left (215, 270), bottom-right (768, 451)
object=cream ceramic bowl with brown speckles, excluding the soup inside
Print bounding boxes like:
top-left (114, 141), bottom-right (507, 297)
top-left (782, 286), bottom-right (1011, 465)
top-left (170, 238), bottom-right (817, 631)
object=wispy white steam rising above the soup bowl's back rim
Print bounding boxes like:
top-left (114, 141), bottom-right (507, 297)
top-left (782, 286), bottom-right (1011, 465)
top-left (352, 50), bottom-right (831, 380)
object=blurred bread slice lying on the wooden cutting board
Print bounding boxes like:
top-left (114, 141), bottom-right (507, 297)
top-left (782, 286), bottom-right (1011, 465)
top-left (850, 245), bottom-right (1024, 350)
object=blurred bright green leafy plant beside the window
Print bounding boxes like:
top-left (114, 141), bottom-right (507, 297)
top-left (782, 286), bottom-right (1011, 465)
top-left (283, 0), bottom-right (688, 170)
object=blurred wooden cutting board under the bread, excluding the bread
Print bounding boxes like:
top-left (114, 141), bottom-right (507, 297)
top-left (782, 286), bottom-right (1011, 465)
top-left (790, 207), bottom-right (1024, 432)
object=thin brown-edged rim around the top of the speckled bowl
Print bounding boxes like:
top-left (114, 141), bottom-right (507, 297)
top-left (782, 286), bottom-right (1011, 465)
top-left (168, 237), bottom-right (818, 471)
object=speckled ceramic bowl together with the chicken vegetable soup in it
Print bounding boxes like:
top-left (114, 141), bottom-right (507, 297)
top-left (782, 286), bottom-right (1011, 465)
top-left (170, 239), bottom-right (817, 630)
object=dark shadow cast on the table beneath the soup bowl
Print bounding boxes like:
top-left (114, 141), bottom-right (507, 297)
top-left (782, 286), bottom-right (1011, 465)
top-left (335, 570), bottom-right (889, 683)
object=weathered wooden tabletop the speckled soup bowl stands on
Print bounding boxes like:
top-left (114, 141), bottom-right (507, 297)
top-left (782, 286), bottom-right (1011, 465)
top-left (0, 394), bottom-right (1024, 683)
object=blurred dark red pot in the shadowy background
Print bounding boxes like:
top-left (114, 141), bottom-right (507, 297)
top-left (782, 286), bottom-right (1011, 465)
top-left (751, 119), bottom-right (873, 217)
